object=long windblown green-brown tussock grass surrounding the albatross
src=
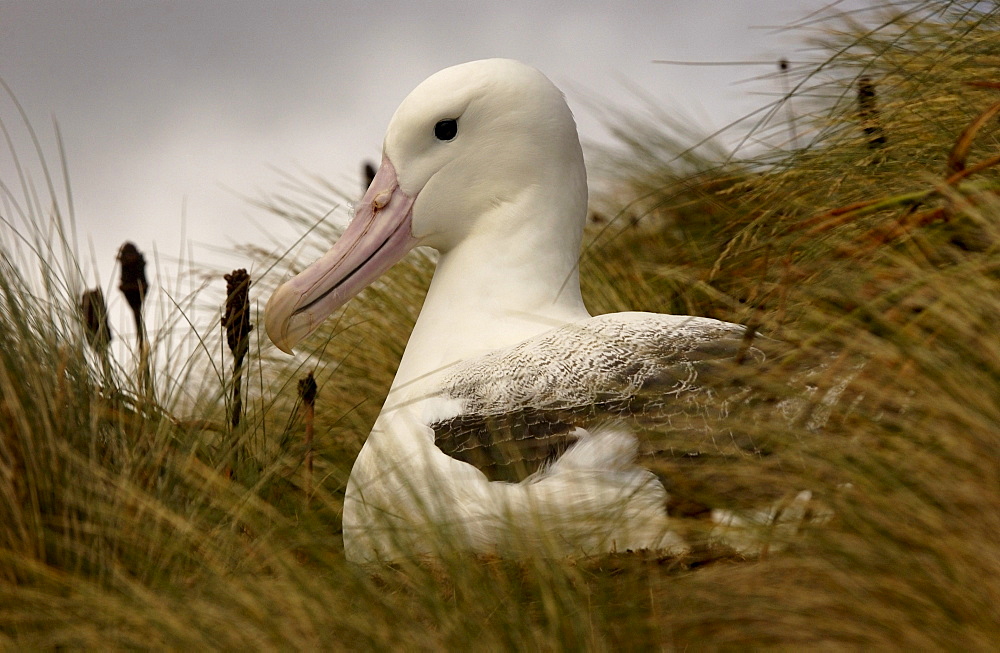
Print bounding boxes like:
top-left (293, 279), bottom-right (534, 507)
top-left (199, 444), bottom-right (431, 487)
top-left (0, 2), bottom-right (1000, 650)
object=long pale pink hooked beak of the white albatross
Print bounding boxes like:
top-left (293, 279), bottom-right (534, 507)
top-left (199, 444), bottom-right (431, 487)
top-left (264, 158), bottom-right (417, 354)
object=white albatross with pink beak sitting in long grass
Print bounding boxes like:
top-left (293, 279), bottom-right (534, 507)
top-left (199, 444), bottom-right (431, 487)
top-left (265, 59), bottom-right (820, 562)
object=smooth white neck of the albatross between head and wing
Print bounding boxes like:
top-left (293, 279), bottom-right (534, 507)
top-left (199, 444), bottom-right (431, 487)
top-left (392, 182), bottom-right (589, 399)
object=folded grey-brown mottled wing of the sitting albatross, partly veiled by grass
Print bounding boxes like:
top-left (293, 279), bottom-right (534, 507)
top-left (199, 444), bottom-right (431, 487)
top-left (431, 313), bottom-right (842, 513)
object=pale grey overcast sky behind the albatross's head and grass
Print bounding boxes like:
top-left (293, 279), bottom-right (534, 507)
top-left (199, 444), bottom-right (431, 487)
top-left (0, 0), bottom-right (858, 306)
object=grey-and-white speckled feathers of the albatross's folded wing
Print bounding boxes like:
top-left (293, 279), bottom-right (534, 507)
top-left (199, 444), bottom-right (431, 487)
top-left (432, 313), bottom-right (779, 482)
